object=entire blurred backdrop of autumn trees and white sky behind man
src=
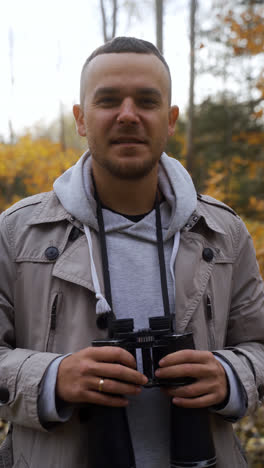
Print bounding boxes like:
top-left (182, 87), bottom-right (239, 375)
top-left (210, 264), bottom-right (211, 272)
top-left (0, 0), bottom-right (264, 468)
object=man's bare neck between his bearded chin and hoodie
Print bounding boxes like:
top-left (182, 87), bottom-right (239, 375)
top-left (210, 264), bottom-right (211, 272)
top-left (92, 164), bottom-right (158, 215)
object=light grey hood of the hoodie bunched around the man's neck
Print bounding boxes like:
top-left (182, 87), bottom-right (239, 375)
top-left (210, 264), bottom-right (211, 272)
top-left (53, 151), bottom-right (197, 240)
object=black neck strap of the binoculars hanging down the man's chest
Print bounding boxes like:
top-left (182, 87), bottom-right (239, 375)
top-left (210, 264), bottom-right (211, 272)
top-left (93, 178), bottom-right (170, 337)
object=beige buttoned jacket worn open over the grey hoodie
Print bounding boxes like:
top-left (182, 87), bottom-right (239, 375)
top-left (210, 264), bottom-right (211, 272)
top-left (0, 192), bottom-right (264, 468)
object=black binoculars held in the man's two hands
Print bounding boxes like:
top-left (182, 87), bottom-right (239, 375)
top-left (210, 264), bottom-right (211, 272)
top-left (86, 316), bottom-right (216, 468)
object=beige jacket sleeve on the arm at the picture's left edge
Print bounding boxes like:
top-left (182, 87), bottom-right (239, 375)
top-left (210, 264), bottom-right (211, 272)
top-left (0, 214), bottom-right (59, 430)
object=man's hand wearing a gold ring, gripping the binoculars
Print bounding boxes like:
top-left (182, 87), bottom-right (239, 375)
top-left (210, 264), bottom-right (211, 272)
top-left (56, 346), bottom-right (148, 407)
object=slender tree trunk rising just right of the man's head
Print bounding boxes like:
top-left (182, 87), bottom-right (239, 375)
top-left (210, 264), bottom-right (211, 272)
top-left (186, 0), bottom-right (197, 173)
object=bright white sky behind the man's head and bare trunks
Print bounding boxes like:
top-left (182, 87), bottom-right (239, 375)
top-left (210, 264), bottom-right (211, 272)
top-left (0, 0), bottom-right (213, 139)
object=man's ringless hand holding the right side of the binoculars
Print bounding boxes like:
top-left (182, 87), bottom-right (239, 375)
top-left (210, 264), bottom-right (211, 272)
top-left (156, 349), bottom-right (228, 408)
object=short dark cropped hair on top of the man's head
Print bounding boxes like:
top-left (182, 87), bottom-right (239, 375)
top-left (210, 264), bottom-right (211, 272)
top-left (80, 36), bottom-right (171, 104)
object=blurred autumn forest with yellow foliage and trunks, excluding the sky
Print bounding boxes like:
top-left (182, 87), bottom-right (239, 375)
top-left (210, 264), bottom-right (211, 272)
top-left (0, 0), bottom-right (264, 468)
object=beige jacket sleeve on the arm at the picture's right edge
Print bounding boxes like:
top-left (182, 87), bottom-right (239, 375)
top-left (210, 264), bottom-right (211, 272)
top-left (214, 220), bottom-right (264, 414)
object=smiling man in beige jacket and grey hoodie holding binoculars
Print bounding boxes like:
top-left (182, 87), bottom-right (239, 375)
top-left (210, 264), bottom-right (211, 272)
top-left (0, 38), bottom-right (264, 468)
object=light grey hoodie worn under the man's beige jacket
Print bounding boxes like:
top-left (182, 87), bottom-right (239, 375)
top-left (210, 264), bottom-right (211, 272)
top-left (54, 153), bottom-right (196, 468)
